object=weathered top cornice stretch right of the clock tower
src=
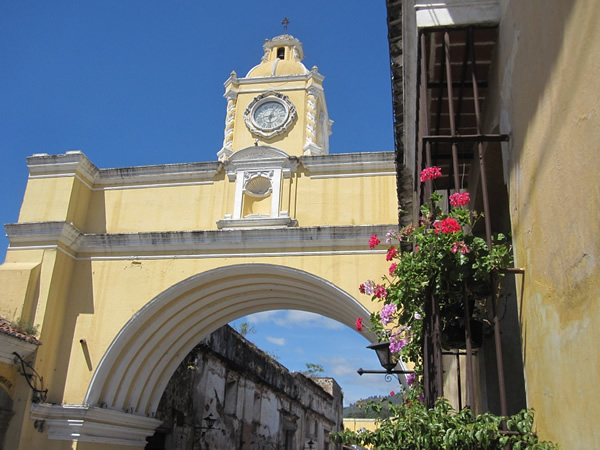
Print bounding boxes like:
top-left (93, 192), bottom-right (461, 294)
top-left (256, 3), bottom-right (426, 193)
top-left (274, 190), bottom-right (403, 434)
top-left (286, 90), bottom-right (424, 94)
top-left (300, 152), bottom-right (396, 176)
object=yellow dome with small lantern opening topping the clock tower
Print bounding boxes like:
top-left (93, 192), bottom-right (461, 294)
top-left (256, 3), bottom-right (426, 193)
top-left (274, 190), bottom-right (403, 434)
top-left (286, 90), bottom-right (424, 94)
top-left (246, 34), bottom-right (309, 78)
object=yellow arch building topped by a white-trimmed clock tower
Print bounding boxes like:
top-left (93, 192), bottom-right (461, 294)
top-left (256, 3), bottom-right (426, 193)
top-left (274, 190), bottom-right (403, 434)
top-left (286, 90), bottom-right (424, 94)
top-left (0, 35), bottom-right (398, 449)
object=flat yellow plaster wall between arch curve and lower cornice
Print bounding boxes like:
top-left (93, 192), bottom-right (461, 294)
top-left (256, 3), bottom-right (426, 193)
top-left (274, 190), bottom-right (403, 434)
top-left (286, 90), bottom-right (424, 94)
top-left (58, 251), bottom-right (389, 404)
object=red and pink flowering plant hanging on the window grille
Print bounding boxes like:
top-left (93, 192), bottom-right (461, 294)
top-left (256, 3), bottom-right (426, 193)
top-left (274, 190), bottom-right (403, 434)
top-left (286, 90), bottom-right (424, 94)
top-left (359, 167), bottom-right (512, 373)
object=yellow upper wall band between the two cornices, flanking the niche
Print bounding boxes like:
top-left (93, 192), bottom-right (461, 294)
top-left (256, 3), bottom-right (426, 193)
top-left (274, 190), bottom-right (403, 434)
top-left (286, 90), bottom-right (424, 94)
top-left (21, 171), bottom-right (397, 233)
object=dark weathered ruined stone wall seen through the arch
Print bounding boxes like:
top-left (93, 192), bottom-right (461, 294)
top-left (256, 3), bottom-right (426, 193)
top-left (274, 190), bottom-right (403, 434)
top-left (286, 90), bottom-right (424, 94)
top-left (147, 326), bottom-right (343, 450)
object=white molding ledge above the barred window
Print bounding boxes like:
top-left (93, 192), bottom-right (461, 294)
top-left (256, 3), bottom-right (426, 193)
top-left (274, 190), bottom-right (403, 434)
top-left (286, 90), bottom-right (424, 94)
top-left (415, 0), bottom-right (500, 28)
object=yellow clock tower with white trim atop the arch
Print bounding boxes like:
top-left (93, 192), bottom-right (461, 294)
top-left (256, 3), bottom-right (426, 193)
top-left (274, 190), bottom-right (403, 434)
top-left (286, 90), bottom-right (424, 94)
top-left (217, 34), bottom-right (332, 162)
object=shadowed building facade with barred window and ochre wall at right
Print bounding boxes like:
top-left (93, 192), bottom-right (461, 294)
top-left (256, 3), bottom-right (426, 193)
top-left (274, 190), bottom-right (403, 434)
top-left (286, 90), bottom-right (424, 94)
top-left (387, 0), bottom-right (600, 448)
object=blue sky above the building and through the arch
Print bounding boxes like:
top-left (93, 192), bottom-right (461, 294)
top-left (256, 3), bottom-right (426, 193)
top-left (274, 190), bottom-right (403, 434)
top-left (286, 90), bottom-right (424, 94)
top-left (0, 0), bottom-right (397, 406)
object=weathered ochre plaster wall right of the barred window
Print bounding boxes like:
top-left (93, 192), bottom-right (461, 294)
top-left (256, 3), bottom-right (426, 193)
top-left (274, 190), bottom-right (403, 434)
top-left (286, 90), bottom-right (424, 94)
top-left (497, 0), bottom-right (600, 448)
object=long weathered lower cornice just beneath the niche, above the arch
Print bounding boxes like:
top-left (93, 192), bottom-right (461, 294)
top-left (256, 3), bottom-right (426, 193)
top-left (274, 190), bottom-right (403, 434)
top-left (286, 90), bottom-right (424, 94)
top-left (6, 222), bottom-right (397, 259)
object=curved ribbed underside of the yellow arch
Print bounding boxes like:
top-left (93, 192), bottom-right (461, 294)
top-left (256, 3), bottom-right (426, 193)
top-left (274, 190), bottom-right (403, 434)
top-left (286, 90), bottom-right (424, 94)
top-left (85, 264), bottom-right (375, 417)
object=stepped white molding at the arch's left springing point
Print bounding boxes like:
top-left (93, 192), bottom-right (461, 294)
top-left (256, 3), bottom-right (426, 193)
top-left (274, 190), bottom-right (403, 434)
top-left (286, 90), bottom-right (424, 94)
top-left (30, 403), bottom-right (162, 448)
